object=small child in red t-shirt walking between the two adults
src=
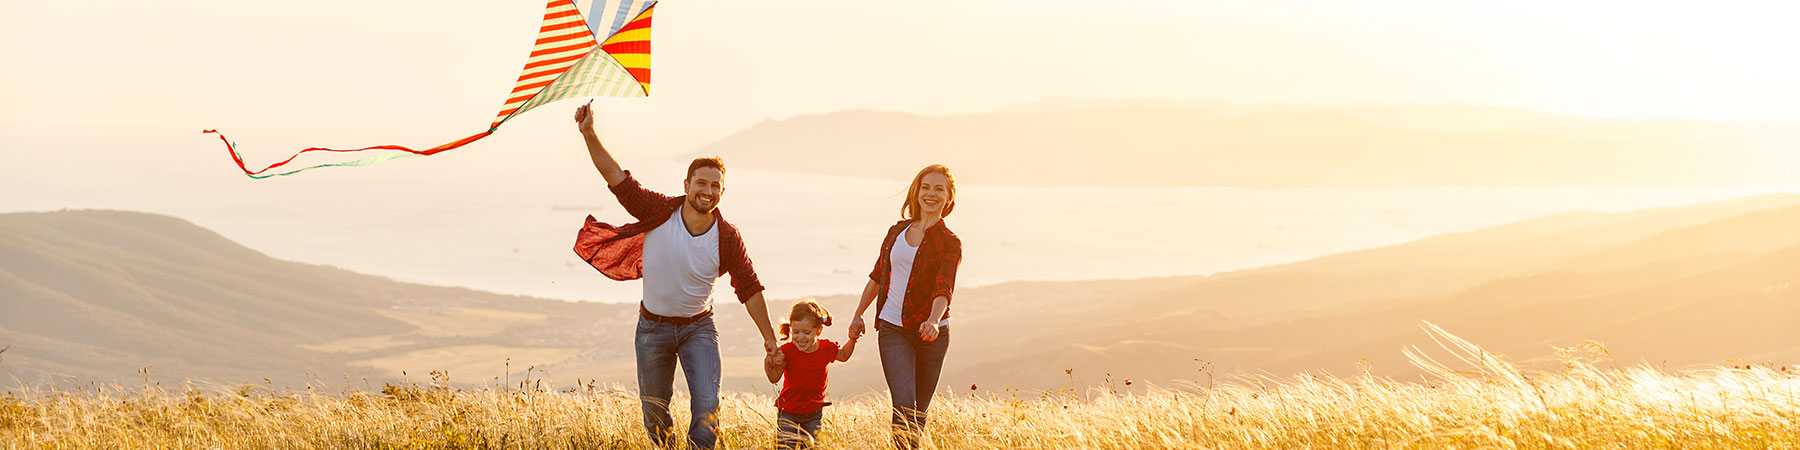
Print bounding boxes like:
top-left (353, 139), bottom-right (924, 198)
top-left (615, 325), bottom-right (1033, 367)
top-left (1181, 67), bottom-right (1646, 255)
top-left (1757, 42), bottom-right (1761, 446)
top-left (763, 299), bottom-right (859, 448)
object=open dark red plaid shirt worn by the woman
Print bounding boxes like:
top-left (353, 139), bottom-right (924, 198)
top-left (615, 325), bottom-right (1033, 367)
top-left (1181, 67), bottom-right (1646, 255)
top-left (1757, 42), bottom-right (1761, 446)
top-left (869, 220), bottom-right (963, 329)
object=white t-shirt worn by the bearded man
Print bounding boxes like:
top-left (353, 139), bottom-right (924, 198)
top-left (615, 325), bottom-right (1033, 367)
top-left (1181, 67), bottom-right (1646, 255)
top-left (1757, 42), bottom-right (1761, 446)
top-left (644, 209), bottom-right (718, 317)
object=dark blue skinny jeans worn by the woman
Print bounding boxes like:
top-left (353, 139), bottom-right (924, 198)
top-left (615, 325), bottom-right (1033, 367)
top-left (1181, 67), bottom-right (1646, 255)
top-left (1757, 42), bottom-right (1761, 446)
top-left (875, 320), bottom-right (950, 448)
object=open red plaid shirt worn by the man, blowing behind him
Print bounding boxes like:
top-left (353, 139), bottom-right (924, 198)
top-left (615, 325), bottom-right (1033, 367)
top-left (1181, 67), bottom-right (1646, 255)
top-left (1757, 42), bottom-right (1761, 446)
top-left (574, 171), bottom-right (763, 302)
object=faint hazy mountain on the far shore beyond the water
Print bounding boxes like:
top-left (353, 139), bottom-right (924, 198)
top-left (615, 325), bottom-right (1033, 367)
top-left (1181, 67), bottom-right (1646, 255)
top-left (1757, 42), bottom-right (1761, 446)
top-left (684, 101), bottom-right (1800, 187)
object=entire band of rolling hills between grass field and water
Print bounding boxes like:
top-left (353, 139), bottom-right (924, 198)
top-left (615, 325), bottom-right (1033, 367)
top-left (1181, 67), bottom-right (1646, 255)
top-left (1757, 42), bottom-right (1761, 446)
top-left (0, 194), bottom-right (1800, 394)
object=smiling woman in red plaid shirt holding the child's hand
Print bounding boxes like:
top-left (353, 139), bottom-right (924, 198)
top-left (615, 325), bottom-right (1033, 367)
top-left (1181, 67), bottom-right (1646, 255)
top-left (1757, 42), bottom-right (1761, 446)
top-left (850, 164), bottom-right (963, 448)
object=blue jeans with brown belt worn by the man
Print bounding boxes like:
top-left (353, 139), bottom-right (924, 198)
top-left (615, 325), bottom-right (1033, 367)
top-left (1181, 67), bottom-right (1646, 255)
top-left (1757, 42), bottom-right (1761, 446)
top-left (634, 315), bottom-right (720, 448)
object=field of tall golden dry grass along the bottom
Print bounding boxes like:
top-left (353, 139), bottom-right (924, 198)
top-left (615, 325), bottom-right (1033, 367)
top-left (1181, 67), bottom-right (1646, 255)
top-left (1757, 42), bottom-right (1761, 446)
top-left (0, 324), bottom-right (1800, 448)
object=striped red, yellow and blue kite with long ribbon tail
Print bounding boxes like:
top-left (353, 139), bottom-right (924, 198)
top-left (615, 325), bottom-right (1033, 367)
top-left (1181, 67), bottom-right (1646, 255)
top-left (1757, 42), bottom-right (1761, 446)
top-left (202, 0), bottom-right (657, 178)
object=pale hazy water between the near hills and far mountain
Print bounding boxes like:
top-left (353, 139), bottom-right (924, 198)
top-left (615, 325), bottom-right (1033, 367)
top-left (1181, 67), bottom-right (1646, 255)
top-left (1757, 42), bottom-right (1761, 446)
top-left (0, 166), bottom-right (1777, 301)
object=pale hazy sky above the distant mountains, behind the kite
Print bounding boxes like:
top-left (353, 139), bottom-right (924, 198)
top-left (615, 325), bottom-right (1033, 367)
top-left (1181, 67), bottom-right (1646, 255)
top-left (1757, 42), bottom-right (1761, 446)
top-left (0, 0), bottom-right (1800, 160)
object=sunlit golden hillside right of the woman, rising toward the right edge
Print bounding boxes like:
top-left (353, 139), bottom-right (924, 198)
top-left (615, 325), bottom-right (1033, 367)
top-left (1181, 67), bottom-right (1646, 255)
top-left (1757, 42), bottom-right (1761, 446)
top-left (956, 194), bottom-right (1800, 385)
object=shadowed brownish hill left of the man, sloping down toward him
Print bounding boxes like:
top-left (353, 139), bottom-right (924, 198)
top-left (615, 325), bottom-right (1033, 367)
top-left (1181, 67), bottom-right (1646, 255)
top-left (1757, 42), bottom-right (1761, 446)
top-left (0, 211), bottom-right (625, 383)
